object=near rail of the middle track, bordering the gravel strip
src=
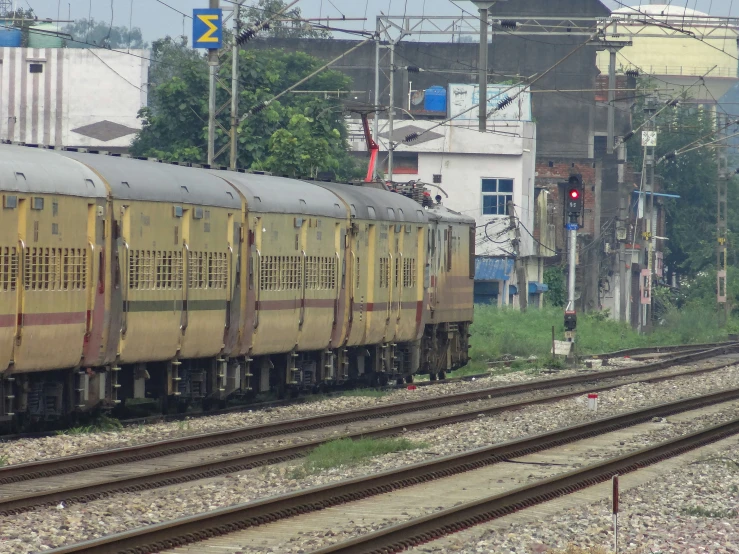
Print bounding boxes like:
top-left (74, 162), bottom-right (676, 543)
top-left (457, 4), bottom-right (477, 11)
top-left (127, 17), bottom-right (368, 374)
top-left (0, 352), bottom-right (736, 515)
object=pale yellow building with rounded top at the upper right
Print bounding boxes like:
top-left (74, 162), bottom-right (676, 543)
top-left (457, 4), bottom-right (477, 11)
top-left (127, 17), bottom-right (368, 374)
top-left (598, 4), bottom-right (739, 102)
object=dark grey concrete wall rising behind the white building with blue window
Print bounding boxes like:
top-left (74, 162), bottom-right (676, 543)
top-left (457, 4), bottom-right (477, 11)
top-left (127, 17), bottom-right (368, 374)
top-left (249, 22), bottom-right (605, 158)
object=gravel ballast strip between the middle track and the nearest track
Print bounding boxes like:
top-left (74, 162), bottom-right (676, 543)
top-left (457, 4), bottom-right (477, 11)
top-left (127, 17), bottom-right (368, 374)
top-left (0, 362), bottom-right (739, 554)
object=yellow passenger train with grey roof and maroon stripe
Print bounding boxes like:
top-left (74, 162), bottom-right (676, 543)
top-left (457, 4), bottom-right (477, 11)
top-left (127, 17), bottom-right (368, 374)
top-left (0, 144), bottom-right (475, 425)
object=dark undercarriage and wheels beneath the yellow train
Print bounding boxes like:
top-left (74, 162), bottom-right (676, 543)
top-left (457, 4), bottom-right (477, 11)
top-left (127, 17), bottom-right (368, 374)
top-left (0, 323), bottom-right (469, 429)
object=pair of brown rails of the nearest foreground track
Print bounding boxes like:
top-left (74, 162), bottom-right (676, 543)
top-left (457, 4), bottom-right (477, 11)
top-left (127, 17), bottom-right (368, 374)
top-left (42, 388), bottom-right (739, 554)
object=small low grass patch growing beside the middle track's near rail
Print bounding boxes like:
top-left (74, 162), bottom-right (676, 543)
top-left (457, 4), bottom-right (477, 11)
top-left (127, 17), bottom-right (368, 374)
top-left (294, 438), bottom-right (427, 478)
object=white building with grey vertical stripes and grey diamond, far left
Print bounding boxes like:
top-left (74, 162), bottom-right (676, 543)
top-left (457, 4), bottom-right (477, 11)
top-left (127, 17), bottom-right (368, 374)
top-left (0, 48), bottom-right (149, 149)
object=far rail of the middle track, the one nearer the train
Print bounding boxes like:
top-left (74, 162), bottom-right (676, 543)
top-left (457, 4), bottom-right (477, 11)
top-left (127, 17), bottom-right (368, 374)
top-left (0, 344), bottom-right (739, 485)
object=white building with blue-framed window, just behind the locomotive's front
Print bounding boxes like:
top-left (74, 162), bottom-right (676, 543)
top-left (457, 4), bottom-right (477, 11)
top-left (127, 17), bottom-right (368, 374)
top-left (350, 89), bottom-right (545, 305)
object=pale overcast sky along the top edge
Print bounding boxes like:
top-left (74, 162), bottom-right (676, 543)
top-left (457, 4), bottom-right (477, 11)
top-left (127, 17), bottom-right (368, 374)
top-left (15, 0), bottom-right (739, 42)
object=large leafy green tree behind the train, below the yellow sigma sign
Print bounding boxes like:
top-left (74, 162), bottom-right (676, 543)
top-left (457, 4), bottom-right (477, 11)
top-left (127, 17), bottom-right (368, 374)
top-left (131, 37), bottom-right (364, 179)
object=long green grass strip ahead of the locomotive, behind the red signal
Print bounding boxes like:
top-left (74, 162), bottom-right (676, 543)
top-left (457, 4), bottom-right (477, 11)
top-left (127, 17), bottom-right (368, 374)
top-left (467, 306), bottom-right (727, 373)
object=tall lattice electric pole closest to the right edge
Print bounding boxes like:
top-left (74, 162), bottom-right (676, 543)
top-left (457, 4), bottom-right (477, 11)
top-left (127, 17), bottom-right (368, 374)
top-left (716, 114), bottom-right (729, 326)
